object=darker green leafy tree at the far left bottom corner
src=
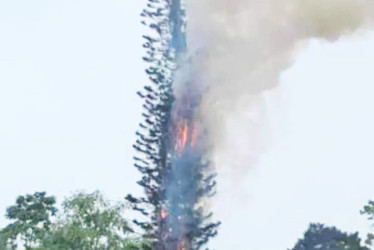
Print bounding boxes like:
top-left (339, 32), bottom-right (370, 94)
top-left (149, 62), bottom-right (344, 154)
top-left (0, 192), bottom-right (57, 249)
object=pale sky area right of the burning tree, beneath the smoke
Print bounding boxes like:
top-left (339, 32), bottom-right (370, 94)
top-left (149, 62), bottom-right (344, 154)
top-left (210, 32), bottom-right (374, 250)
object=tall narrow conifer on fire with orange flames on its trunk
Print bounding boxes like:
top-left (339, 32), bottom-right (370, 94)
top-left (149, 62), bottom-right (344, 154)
top-left (126, 0), bottom-right (219, 250)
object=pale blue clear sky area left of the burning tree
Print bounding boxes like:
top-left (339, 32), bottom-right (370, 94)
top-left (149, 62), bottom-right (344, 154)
top-left (0, 0), bottom-right (146, 224)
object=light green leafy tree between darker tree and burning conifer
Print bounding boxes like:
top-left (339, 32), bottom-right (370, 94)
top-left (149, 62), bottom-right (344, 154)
top-left (42, 192), bottom-right (145, 250)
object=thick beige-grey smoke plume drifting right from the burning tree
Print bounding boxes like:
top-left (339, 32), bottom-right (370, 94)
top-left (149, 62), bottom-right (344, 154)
top-left (182, 0), bottom-right (374, 250)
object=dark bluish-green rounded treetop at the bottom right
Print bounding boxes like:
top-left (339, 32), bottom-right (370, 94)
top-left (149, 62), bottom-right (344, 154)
top-left (292, 224), bottom-right (369, 250)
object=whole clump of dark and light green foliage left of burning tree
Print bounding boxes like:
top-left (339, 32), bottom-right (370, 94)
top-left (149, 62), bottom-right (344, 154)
top-left (0, 192), bottom-right (149, 250)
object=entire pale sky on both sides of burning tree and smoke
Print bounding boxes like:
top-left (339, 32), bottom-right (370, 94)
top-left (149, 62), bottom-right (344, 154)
top-left (0, 0), bottom-right (374, 250)
